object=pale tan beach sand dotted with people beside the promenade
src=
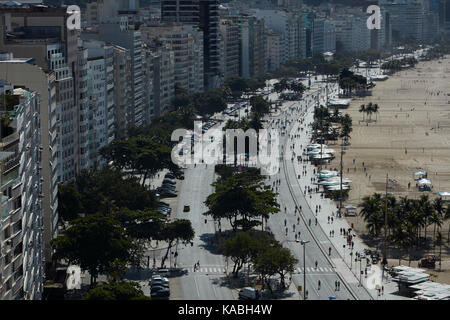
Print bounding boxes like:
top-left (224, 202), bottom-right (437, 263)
top-left (327, 56), bottom-right (450, 283)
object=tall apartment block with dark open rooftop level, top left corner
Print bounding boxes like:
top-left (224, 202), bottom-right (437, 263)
top-left (0, 6), bottom-right (79, 183)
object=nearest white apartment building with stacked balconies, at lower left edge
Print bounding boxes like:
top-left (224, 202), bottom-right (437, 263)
top-left (0, 80), bottom-right (44, 300)
